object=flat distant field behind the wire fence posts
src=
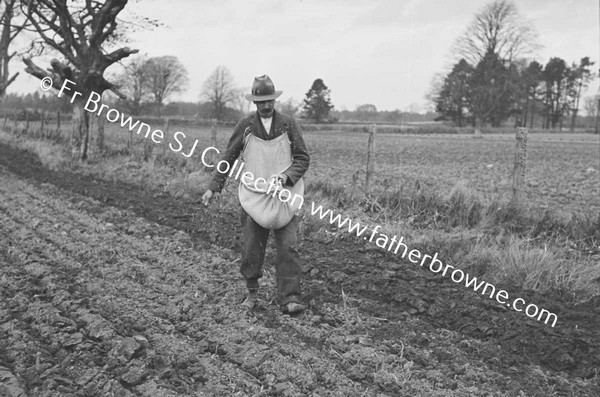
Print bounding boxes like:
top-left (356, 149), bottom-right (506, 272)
top-left (44, 123), bottom-right (600, 214)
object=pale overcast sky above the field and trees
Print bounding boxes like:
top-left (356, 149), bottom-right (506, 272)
top-left (9, 0), bottom-right (600, 110)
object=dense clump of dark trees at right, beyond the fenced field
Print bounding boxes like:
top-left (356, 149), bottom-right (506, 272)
top-left (435, 51), bottom-right (595, 130)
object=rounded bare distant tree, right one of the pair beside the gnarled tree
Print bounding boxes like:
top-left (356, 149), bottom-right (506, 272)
top-left (144, 55), bottom-right (188, 115)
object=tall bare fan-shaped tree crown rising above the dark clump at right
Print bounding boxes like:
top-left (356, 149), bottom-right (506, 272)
top-left (454, 0), bottom-right (537, 65)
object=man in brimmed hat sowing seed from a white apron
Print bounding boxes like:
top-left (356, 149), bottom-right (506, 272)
top-left (202, 75), bottom-right (310, 313)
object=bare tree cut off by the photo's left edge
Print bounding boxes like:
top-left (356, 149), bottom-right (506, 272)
top-left (0, 0), bottom-right (26, 97)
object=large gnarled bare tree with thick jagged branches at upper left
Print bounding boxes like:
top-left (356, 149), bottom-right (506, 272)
top-left (21, 0), bottom-right (138, 160)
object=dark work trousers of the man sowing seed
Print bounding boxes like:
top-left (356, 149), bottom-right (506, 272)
top-left (240, 209), bottom-right (301, 305)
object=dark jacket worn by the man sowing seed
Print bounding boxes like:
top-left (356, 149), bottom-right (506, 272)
top-left (208, 111), bottom-right (310, 192)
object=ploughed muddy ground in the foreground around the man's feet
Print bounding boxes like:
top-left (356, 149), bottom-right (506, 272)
top-left (0, 144), bottom-right (600, 396)
